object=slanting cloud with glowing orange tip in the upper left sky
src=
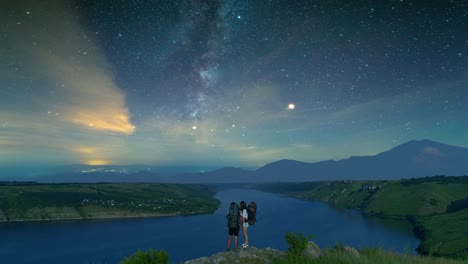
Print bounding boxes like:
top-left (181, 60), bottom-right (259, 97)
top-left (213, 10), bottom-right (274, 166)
top-left (5, 1), bottom-right (134, 135)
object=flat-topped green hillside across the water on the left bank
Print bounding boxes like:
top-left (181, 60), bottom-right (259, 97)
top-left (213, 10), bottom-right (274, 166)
top-left (0, 183), bottom-right (219, 221)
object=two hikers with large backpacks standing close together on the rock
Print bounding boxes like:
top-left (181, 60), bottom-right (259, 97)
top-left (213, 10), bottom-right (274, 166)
top-left (226, 201), bottom-right (257, 251)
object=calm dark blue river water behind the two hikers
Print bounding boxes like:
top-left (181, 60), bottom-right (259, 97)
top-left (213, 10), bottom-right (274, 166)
top-left (0, 189), bottom-right (418, 263)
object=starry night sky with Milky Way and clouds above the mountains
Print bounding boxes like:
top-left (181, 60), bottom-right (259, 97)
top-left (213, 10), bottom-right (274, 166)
top-left (0, 0), bottom-right (468, 171)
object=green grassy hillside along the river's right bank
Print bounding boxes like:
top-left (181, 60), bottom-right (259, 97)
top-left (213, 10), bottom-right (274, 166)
top-left (258, 176), bottom-right (468, 259)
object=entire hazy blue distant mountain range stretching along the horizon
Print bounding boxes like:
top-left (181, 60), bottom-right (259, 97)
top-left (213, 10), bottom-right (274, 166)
top-left (26, 140), bottom-right (468, 183)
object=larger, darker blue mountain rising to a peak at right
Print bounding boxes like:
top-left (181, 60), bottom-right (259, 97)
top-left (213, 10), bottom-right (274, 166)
top-left (256, 140), bottom-right (468, 181)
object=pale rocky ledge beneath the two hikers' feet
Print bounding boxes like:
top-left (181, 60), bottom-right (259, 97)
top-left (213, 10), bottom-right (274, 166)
top-left (185, 247), bottom-right (285, 264)
